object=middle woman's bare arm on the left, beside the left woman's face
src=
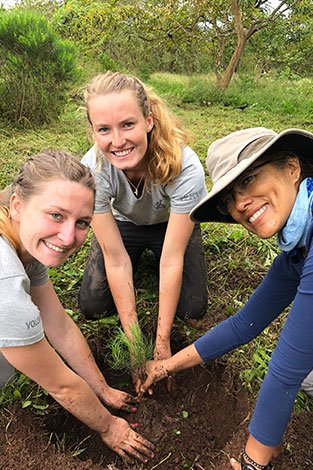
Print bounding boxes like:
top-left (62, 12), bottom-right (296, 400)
top-left (92, 212), bottom-right (137, 337)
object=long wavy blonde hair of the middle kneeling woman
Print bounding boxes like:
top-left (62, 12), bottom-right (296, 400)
top-left (84, 71), bottom-right (188, 185)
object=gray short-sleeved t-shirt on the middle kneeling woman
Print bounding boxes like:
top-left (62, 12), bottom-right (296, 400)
top-left (82, 145), bottom-right (207, 225)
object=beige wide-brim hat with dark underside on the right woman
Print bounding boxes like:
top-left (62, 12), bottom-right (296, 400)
top-left (190, 127), bottom-right (313, 223)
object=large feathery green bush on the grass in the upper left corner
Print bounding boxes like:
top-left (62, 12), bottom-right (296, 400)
top-left (0, 11), bottom-right (77, 125)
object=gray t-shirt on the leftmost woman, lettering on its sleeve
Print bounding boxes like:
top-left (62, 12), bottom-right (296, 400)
top-left (0, 236), bottom-right (49, 386)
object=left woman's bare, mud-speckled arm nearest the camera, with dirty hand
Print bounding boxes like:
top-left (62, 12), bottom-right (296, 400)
top-left (1, 339), bottom-right (153, 462)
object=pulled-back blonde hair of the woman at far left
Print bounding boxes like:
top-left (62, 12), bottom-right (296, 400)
top-left (0, 150), bottom-right (95, 251)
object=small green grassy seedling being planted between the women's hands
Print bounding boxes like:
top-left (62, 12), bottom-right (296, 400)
top-left (107, 323), bottom-right (153, 371)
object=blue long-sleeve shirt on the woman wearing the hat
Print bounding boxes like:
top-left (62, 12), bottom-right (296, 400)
top-left (195, 225), bottom-right (313, 447)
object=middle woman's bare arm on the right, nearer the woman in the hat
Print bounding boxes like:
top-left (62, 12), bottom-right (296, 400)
top-left (155, 212), bottom-right (194, 359)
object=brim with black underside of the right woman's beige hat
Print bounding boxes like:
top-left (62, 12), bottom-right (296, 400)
top-left (190, 129), bottom-right (313, 223)
